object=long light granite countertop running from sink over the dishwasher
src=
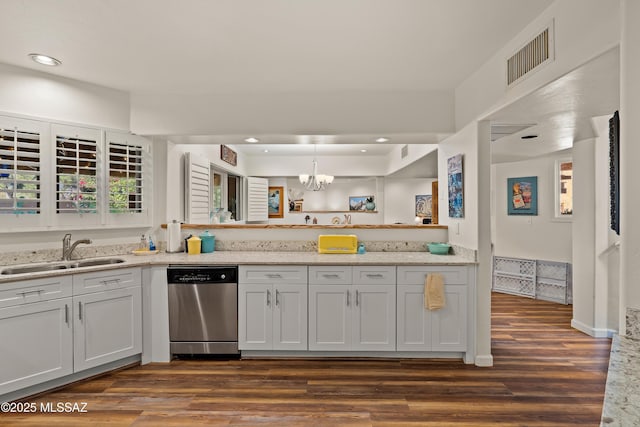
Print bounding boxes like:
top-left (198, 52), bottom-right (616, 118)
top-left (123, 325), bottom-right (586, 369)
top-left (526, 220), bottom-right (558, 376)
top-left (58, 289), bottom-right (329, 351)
top-left (0, 251), bottom-right (477, 283)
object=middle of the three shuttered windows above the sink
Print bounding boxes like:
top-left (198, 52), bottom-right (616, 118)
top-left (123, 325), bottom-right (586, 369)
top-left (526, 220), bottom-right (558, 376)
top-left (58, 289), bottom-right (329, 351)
top-left (56, 132), bottom-right (98, 214)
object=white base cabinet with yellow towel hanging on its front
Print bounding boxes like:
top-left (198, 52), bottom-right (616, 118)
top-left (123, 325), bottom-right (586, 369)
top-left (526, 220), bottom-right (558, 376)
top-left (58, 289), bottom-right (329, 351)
top-left (397, 266), bottom-right (468, 351)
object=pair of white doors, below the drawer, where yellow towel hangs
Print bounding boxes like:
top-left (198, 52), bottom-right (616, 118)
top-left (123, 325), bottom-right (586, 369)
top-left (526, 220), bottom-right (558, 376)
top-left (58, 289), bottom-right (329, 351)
top-left (397, 285), bottom-right (467, 351)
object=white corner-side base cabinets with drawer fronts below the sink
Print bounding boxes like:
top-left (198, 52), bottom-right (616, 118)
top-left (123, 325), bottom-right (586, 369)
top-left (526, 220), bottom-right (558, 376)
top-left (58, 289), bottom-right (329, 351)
top-left (0, 268), bottom-right (142, 395)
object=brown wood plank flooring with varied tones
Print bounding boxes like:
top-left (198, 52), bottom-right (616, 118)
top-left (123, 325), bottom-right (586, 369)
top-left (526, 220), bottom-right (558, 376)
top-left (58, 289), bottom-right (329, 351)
top-left (0, 294), bottom-right (610, 427)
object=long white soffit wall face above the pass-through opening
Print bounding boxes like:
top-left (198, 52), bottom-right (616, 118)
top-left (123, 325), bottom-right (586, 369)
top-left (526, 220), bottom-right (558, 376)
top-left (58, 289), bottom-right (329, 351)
top-left (131, 90), bottom-right (454, 135)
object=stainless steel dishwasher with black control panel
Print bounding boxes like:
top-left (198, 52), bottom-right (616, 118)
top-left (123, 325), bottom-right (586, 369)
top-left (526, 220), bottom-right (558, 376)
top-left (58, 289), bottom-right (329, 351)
top-left (167, 265), bottom-right (239, 354)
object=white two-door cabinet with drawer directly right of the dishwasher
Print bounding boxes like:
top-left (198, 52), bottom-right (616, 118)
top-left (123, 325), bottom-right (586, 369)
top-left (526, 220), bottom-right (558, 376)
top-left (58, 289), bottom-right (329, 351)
top-left (238, 266), bottom-right (307, 350)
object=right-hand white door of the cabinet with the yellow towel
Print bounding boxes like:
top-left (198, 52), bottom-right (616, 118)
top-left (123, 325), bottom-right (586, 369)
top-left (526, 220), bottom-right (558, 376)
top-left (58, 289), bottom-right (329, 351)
top-left (431, 285), bottom-right (467, 351)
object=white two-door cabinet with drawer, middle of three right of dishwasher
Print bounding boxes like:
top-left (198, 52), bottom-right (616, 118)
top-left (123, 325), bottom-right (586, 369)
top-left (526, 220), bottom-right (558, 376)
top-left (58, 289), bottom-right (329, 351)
top-left (309, 266), bottom-right (396, 351)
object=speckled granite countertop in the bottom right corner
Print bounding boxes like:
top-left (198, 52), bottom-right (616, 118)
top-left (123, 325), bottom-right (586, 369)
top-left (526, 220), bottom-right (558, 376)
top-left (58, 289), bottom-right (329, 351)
top-left (600, 335), bottom-right (640, 426)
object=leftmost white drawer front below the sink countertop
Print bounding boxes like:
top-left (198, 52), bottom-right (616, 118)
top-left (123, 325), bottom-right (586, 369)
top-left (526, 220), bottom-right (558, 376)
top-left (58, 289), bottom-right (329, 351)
top-left (0, 275), bottom-right (73, 307)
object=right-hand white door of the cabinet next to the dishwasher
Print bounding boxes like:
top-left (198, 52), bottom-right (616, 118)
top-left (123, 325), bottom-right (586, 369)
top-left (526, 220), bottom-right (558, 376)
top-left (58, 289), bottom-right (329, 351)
top-left (273, 284), bottom-right (308, 350)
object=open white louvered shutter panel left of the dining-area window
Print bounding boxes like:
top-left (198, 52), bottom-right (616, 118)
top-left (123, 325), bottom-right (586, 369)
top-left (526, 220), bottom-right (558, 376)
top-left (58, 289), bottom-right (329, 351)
top-left (184, 153), bottom-right (211, 224)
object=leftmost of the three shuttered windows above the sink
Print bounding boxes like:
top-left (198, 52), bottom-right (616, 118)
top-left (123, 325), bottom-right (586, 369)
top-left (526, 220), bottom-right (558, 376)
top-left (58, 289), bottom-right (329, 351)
top-left (0, 128), bottom-right (41, 215)
